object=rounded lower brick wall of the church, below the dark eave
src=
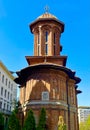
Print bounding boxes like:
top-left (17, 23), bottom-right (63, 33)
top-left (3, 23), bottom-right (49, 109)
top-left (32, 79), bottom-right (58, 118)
top-left (20, 69), bottom-right (77, 130)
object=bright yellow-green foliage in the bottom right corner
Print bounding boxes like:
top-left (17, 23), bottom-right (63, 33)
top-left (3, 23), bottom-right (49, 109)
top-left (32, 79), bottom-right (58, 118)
top-left (79, 116), bottom-right (90, 130)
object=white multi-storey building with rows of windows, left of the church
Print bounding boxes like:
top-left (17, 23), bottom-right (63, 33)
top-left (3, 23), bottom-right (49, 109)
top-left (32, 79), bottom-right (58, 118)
top-left (0, 61), bottom-right (17, 122)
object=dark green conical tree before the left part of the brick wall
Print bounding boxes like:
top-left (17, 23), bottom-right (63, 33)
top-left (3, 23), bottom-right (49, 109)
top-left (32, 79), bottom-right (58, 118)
top-left (23, 109), bottom-right (36, 130)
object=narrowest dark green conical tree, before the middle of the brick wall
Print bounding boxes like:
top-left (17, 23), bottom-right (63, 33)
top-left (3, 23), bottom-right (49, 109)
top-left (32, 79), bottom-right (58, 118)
top-left (37, 108), bottom-right (46, 130)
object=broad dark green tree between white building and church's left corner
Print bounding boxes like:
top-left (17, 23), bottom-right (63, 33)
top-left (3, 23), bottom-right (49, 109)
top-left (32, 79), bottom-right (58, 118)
top-left (8, 111), bottom-right (21, 130)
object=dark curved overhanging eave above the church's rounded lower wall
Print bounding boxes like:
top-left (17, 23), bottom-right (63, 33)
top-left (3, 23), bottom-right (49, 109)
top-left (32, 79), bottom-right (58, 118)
top-left (15, 63), bottom-right (81, 85)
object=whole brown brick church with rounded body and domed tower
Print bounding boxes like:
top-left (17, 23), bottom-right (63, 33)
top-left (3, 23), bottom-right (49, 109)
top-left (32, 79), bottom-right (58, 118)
top-left (15, 12), bottom-right (81, 130)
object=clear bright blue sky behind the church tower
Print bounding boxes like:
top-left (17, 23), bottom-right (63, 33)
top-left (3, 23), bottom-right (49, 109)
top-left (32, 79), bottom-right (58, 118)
top-left (0, 0), bottom-right (90, 106)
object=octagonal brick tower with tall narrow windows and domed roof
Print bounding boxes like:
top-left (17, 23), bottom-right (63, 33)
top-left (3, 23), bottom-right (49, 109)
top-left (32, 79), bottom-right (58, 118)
top-left (30, 13), bottom-right (64, 56)
